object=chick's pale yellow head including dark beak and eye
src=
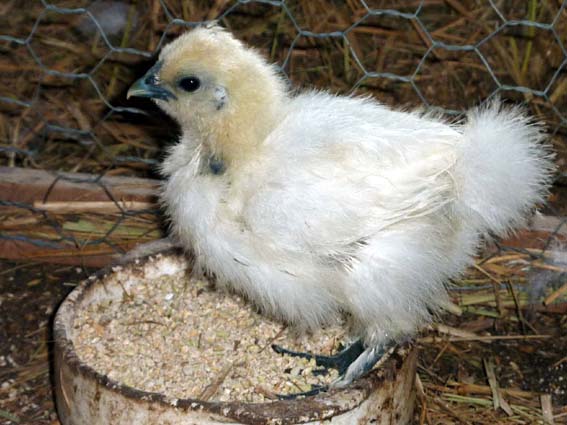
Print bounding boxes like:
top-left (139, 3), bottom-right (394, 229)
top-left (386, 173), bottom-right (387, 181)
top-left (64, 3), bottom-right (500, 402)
top-left (128, 26), bottom-right (286, 160)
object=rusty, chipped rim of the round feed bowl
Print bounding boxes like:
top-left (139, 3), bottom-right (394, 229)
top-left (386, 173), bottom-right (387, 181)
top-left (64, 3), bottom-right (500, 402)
top-left (53, 250), bottom-right (409, 424)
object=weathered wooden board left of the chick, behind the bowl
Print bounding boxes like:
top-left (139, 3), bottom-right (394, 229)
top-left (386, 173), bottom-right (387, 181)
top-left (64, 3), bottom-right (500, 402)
top-left (0, 167), bottom-right (160, 267)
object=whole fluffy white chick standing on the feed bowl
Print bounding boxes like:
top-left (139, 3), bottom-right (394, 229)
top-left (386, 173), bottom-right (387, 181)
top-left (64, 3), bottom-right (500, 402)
top-left (128, 26), bottom-right (554, 387)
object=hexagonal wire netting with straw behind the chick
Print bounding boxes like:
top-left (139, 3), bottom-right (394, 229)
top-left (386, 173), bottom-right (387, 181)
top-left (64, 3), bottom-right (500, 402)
top-left (0, 0), bottom-right (567, 260)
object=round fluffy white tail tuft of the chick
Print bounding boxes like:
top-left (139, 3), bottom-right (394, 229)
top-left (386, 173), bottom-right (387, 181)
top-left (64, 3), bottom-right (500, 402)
top-left (455, 101), bottom-right (555, 235)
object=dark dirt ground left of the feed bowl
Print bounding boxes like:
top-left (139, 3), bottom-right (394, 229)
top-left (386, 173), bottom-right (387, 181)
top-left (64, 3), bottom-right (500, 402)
top-left (0, 261), bottom-right (86, 425)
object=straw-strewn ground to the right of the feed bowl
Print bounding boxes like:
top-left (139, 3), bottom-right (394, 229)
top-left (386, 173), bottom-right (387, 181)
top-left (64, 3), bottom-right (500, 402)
top-left (418, 240), bottom-right (567, 424)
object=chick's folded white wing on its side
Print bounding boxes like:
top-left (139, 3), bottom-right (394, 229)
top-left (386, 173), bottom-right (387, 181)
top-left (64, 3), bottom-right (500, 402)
top-left (237, 95), bottom-right (459, 256)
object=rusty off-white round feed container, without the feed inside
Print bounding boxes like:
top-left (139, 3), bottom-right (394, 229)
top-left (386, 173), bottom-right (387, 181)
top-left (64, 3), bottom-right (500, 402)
top-left (54, 253), bottom-right (417, 425)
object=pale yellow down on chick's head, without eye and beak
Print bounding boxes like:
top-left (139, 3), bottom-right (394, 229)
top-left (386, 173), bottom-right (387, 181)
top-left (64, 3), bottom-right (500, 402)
top-left (158, 26), bottom-right (287, 167)
